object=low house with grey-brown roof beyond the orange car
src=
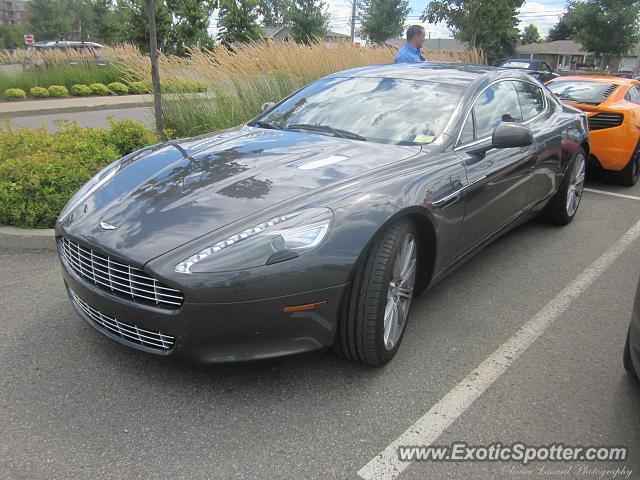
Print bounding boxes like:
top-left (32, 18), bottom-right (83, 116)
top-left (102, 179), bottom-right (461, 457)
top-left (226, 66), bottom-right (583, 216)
top-left (517, 40), bottom-right (640, 72)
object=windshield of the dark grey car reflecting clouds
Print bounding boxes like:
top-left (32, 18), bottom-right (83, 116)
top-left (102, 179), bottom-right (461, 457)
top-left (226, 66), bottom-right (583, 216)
top-left (250, 77), bottom-right (464, 145)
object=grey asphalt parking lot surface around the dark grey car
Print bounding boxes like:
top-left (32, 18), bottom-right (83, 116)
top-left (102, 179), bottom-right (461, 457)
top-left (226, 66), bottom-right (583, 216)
top-left (0, 176), bottom-right (640, 479)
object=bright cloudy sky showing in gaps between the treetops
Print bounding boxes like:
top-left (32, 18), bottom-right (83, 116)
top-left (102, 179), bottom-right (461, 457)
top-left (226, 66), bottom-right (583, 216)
top-left (325, 0), bottom-right (566, 38)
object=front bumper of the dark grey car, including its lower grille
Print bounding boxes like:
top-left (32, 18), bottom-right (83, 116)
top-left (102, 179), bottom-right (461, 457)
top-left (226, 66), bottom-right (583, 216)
top-left (61, 253), bottom-right (347, 363)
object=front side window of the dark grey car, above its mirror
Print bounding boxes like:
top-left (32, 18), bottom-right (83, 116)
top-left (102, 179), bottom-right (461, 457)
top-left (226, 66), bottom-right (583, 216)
top-left (473, 81), bottom-right (522, 139)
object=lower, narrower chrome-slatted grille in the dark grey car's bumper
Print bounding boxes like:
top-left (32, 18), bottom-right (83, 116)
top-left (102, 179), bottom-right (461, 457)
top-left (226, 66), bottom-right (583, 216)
top-left (69, 290), bottom-right (175, 351)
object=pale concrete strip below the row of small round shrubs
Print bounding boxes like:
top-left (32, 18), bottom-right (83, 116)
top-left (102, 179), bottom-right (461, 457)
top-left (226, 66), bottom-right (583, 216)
top-left (0, 95), bottom-right (152, 118)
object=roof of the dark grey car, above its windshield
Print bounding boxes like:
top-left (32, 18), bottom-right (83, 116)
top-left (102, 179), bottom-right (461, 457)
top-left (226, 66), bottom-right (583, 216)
top-left (329, 61), bottom-right (526, 87)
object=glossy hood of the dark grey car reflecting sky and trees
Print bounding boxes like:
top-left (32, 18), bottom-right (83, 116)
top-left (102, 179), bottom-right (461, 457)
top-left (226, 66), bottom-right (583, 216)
top-left (57, 127), bottom-right (421, 266)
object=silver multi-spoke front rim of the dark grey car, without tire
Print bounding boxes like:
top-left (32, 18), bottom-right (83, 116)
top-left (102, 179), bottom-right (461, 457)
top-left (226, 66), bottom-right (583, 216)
top-left (384, 233), bottom-right (417, 350)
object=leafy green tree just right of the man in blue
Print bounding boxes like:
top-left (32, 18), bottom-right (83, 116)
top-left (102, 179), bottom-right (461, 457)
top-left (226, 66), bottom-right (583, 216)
top-left (421, 0), bottom-right (524, 64)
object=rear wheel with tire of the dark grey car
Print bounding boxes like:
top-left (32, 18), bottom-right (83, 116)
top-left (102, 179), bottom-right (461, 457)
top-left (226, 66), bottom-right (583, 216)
top-left (543, 148), bottom-right (587, 225)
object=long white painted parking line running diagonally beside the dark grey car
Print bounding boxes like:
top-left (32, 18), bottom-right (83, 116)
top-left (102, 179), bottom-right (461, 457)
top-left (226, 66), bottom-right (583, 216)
top-left (358, 221), bottom-right (640, 480)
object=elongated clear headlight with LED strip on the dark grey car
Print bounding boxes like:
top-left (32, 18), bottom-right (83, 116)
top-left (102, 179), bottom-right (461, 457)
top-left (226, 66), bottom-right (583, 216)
top-left (174, 208), bottom-right (333, 273)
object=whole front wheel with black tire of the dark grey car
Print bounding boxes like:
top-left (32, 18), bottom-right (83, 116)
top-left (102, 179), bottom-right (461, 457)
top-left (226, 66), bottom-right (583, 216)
top-left (334, 220), bottom-right (419, 366)
